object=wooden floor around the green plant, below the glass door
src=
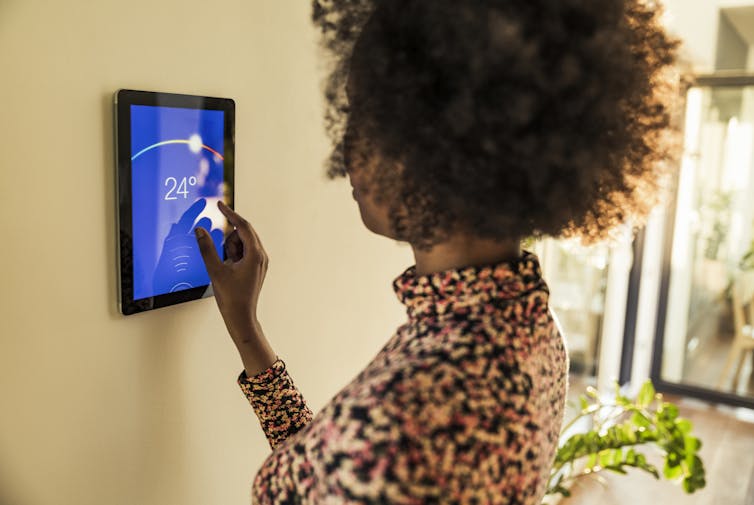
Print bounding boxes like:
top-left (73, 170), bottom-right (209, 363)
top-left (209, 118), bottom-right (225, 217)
top-left (559, 395), bottom-right (754, 505)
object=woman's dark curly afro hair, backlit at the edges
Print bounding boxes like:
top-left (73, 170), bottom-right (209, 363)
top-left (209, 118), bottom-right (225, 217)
top-left (312, 0), bottom-right (681, 249)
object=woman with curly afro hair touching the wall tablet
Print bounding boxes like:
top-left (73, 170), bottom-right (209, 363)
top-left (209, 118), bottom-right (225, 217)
top-left (191, 0), bottom-right (676, 504)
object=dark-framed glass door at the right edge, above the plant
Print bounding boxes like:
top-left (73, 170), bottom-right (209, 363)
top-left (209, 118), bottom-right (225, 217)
top-left (652, 76), bottom-right (754, 407)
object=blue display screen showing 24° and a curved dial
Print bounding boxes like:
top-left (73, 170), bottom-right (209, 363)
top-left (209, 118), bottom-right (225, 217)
top-left (131, 105), bottom-right (226, 300)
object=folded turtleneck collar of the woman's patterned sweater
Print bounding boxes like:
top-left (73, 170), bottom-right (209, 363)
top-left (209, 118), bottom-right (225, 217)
top-left (393, 251), bottom-right (547, 319)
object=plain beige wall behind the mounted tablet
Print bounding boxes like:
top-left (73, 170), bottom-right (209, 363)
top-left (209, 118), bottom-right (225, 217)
top-left (0, 0), bottom-right (413, 505)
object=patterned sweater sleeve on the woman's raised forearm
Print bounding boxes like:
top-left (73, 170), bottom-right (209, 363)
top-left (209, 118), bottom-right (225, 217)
top-left (238, 358), bottom-right (313, 449)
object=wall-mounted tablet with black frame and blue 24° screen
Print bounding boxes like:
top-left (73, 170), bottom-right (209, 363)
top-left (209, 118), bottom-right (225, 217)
top-left (115, 89), bottom-right (235, 315)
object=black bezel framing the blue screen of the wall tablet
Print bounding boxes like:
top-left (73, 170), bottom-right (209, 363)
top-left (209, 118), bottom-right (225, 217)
top-left (114, 89), bottom-right (235, 315)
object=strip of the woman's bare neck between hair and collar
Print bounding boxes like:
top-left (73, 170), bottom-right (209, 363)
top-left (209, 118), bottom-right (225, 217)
top-left (411, 234), bottom-right (521, 275)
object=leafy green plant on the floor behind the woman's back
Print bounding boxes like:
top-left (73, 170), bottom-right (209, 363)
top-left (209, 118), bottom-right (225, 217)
top-left (547, 381), bottom-right (705, 502)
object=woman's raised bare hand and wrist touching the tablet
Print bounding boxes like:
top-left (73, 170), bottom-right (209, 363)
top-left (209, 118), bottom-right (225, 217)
top-left (195, 202), bottom-right (277, 377)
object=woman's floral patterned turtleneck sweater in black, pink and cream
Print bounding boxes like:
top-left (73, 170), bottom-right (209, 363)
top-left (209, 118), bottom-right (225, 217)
top-left (238, 251), bottom-right (568, 505)
